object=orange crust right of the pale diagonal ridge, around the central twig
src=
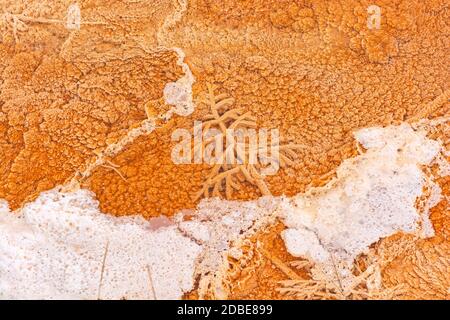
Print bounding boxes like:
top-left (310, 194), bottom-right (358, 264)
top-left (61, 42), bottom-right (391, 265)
top-left (86, 1), bottom-right (449, 216)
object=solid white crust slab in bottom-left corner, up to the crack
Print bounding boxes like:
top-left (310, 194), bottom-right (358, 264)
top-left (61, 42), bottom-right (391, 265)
top-left (0, 190), bottom-right (201, 299)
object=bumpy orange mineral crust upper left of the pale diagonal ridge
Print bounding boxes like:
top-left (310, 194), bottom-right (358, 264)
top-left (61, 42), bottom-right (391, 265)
top-left (0, 1), bottom-right (181, 208)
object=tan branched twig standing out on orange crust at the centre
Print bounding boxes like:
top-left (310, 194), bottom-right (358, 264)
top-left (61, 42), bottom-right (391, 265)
top-left (193, 84), bottom-right (304, 201)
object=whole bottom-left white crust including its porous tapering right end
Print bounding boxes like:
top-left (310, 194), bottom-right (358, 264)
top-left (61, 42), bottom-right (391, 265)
top-left (0, 189), bottom-right (278, 299)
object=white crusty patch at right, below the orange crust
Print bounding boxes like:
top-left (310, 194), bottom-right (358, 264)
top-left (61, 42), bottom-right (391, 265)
top-left (282, 124), bottom-right (442, 288)
